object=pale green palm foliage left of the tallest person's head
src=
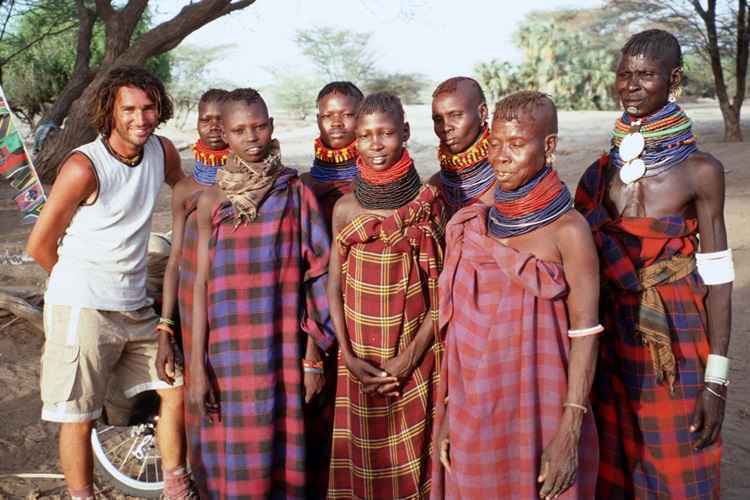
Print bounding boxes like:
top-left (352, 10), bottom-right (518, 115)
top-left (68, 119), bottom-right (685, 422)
top-left (474, 11), bottom-right (617, 109)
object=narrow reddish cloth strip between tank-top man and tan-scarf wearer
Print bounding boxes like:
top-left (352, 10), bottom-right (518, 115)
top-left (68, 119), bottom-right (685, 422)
top-left (177, 191), bottom-right (205, 494)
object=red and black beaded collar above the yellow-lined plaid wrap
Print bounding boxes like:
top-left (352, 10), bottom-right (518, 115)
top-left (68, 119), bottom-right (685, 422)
top-left (354, 148), bottom-right (422, 210)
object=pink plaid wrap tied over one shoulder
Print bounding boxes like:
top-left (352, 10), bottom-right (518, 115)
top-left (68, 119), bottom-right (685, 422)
top-left (432, 204), bottom-right (598, 500)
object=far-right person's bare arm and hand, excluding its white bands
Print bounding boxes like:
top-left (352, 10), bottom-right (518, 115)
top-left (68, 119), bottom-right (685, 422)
top-left (690, 155), bottom-right (732, 448)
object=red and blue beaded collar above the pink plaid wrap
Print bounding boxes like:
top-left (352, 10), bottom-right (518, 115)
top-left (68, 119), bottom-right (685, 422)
top-left (487, 165), bottom-right (573, 238)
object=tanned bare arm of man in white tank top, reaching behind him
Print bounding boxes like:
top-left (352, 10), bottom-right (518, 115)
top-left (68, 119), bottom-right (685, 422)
top-left (26, 153), bottom-right (98, 273)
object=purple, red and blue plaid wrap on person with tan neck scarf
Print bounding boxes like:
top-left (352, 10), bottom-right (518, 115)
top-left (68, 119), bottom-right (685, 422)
top-left (203, 169), bottom-right (334, 499)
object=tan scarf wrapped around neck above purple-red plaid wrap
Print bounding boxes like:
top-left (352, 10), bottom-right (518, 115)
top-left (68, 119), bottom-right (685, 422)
top-left (216, 139), bottom-right (283, 228)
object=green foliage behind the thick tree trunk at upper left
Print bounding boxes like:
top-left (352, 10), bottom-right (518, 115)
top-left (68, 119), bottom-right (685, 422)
top-left (0, 0), bottom-right (171, 126)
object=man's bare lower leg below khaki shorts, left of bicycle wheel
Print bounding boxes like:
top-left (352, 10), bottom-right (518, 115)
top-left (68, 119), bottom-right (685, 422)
top-left (60, 421), bottom-right (94, 499)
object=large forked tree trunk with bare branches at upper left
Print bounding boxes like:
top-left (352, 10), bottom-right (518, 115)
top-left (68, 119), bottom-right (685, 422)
top-left (0, 0), bottom-right (262, 181)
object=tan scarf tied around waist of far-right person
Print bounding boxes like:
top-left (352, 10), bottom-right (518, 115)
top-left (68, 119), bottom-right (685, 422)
top-left (636, 255), bottom-right (695, 393)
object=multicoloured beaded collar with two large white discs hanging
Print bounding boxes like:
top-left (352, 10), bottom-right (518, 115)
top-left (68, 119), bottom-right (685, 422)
top-left (610, 102), bottom-right (698, 184)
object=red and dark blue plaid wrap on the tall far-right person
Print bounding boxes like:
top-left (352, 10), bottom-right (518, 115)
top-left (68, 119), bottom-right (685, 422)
top-left (576, 156), bottom-right (721, 499)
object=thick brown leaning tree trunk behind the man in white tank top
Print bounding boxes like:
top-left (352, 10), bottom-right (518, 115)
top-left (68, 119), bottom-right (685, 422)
top-left (34, 0), bottom-right (255, 183)
